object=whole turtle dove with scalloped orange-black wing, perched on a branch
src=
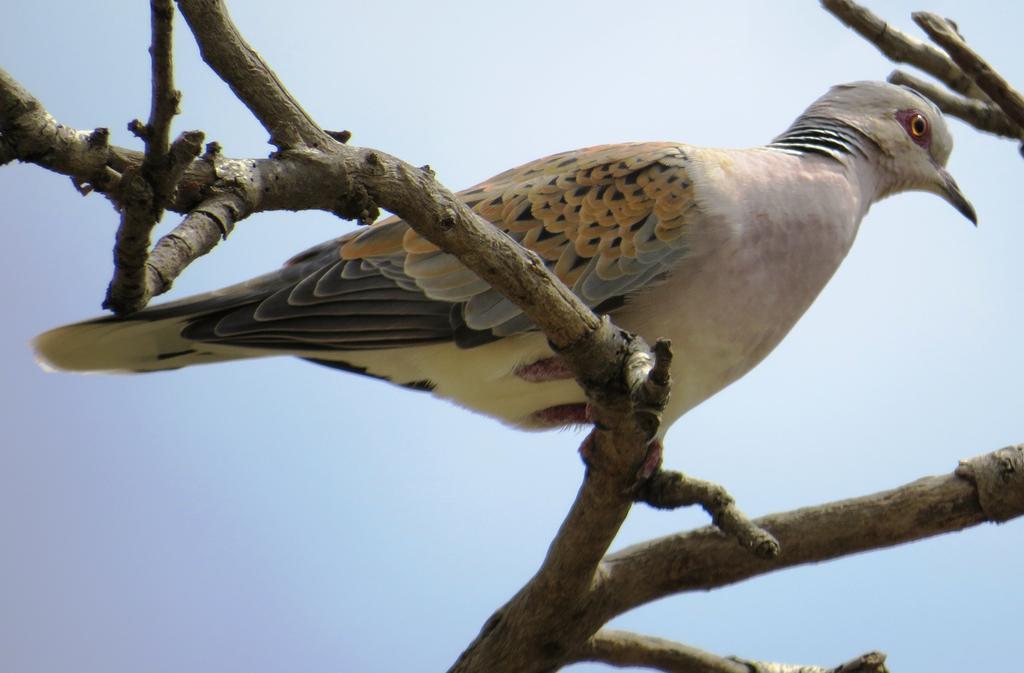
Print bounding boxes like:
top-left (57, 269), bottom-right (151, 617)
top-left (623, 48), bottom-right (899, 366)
top-left (35, 82), bottom-right (977, 436)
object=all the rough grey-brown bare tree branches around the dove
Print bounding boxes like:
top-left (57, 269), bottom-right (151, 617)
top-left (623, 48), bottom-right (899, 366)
top-left (0, 0), bottom-right (1024, 673)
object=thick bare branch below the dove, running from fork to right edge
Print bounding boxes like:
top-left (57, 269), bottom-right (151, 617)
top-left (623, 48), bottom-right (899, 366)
top-left (595, 445), bottom-right (1024, 623)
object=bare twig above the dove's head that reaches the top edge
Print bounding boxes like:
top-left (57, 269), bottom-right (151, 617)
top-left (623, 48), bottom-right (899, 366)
top-left (821, 0), bottom-right (986, 100)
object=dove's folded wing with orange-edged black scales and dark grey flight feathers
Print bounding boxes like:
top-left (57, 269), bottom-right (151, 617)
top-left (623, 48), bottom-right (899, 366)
top-left (184, 142), bottom-right (697, 350)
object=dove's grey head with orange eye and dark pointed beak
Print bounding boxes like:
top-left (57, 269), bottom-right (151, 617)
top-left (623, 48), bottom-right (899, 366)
top-left (807, 82), bottom-right (978, 224)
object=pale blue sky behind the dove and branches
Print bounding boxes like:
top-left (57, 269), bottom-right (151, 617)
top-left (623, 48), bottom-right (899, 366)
top-left (0, 0), bottom-right (1024, 673)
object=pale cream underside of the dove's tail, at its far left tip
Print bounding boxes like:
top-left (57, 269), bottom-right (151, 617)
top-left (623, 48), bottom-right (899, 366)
top-left (32, 317), bottom-right (256, 373)
